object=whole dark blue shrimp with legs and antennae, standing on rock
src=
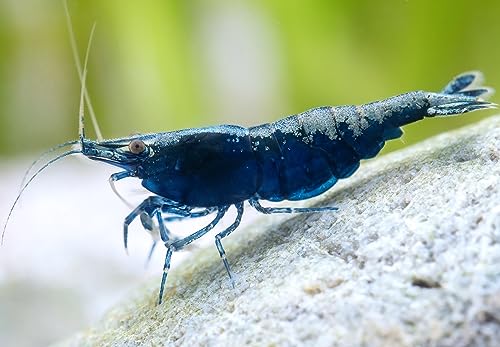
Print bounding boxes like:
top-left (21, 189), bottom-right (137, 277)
top-left (4, 23), bottom-right (496, 304)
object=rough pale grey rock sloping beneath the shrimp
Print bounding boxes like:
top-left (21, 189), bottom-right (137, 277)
top-left (61, 117), bottom-right (500, 346)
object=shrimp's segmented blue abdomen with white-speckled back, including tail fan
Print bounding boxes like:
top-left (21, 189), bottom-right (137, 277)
top-left (249, 73), bottom-right (494, 201)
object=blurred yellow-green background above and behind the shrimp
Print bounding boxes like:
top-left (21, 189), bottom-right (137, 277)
top-left (0, 0), bottom-right (500, 156)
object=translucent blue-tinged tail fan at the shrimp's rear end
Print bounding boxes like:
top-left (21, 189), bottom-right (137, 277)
top-left (427, 71), bottom-right (497, 117)
